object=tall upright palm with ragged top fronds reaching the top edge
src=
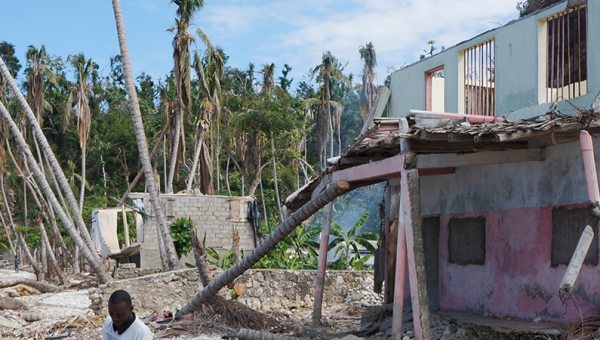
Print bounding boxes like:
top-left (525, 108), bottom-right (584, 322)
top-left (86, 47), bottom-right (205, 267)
top-left (165, 0), bottom-right (204, 193)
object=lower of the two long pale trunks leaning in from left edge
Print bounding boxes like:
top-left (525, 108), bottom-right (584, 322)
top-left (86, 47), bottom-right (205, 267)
top-left (0, 99), bottom-right (110, 283)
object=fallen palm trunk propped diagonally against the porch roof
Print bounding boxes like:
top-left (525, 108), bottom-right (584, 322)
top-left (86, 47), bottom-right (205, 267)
top-left (177, 181), bottom-right (350, 317)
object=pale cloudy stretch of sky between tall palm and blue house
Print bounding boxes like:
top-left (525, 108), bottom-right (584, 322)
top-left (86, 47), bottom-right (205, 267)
top-left (197, 0), bottom-right (517, 86)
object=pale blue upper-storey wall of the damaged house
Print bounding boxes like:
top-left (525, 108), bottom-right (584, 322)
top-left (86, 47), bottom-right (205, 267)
top-left (389, 1), bottom-right (600, 120)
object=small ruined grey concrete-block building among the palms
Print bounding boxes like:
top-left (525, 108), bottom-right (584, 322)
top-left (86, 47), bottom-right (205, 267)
top-left (92, 193), bottom-right (258, 269)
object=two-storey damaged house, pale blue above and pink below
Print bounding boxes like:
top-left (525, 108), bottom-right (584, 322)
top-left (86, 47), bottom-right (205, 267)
top-left (286, 1), bottom-right (600, 338)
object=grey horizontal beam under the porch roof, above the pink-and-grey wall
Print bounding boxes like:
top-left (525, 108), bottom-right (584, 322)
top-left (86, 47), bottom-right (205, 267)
top-left (417, 148), bottom-right (546, 169)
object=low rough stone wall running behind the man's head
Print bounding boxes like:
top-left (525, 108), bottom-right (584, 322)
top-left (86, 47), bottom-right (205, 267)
top-left (89, 269), bottom-right (381, 316)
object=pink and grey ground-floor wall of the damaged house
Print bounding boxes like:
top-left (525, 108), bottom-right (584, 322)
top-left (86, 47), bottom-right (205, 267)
top-left (421, 140), bottom-right (600, 321)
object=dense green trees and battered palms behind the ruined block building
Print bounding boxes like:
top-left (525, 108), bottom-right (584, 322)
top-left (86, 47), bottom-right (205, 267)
top-left (0, 0), bottom-right (382, 278)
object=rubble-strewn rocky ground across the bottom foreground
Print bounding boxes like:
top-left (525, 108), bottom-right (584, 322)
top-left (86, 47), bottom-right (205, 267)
top-left (0, 270), bottom-right (572, 340)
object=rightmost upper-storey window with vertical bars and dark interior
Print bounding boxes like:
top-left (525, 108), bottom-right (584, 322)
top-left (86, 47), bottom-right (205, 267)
top-left (546, 6), bottom-right (588, 102)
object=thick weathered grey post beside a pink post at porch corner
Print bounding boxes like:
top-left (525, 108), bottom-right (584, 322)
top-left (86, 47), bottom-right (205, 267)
top-left (400, 169), bottom-right (431, 340)
